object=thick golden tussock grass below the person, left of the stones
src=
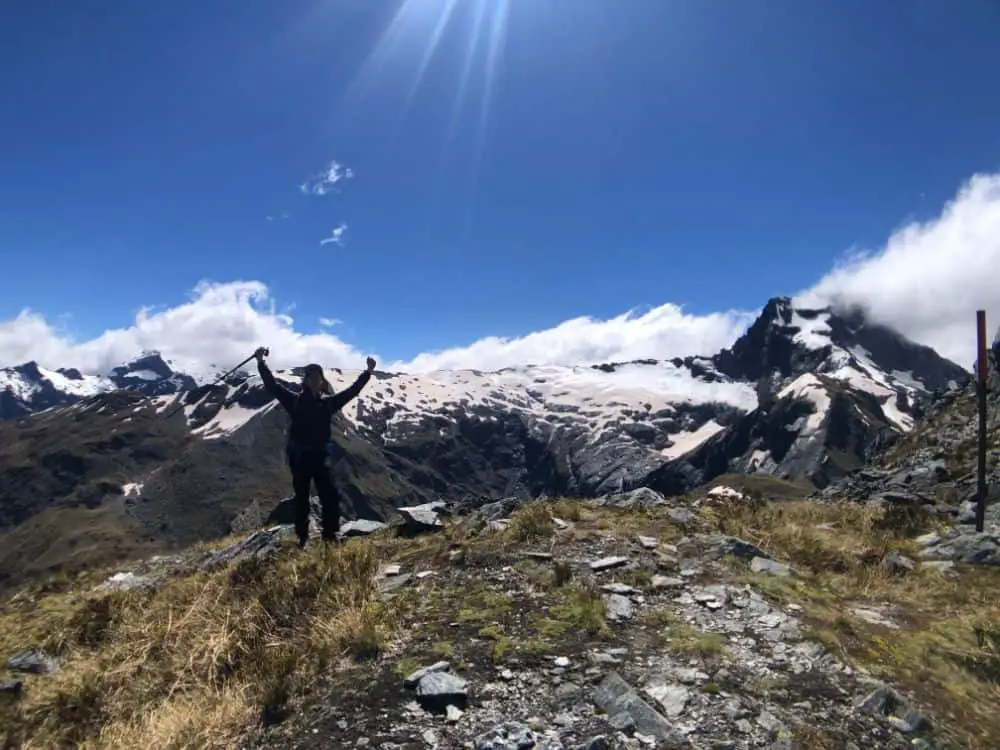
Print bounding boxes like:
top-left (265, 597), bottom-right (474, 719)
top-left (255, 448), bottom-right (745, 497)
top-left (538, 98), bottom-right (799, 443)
top-left (0, 541), bottom-right (395, 750)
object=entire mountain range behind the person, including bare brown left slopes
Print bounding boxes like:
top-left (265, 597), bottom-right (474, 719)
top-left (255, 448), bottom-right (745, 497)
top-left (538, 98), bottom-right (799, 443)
top-left (0, 298), bottom-right (969, 592)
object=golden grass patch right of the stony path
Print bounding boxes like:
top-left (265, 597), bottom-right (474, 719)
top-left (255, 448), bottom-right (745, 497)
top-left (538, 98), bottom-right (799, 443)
top-left (700, 501), bottom-right (1000, 750)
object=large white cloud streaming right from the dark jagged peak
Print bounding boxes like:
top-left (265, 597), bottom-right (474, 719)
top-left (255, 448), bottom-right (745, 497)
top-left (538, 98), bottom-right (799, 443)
top-left (797, 174), bottom-right (1000, 367)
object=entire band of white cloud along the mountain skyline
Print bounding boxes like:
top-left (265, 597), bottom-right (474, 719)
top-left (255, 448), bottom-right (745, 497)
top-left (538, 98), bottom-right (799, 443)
top-left (0, 175), bottom-right (1000, 382)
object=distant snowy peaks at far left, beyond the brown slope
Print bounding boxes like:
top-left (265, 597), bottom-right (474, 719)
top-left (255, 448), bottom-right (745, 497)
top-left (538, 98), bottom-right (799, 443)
top-left (0, 352), bottom-right (196, 419)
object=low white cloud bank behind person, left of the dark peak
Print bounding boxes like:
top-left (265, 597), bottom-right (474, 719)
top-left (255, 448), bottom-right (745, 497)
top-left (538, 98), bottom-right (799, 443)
top-left (0, 281), bottom-right (754, 375)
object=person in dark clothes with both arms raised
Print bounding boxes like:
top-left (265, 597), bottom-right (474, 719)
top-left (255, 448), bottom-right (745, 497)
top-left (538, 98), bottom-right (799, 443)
top-left (254, 346), bottom-right (375, 547)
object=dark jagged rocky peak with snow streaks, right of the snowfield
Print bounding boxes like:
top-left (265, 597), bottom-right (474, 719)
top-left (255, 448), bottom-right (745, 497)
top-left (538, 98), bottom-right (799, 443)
top-left (632, 297), bottom-right (971, 492)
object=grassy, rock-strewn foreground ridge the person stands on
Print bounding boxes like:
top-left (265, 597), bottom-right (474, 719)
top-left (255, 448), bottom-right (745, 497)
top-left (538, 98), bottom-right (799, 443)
top-left (0, 483), bottom-right (1000, 750)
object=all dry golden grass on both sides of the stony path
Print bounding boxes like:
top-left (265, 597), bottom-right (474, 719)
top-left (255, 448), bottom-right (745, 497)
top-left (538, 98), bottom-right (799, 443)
top-left (7, 494), bottom-right (1000, 749)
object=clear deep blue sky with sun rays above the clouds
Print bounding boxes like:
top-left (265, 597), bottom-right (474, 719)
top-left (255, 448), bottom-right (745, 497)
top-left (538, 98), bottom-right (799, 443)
top-left (0, 0), bottom-right (1000, 370)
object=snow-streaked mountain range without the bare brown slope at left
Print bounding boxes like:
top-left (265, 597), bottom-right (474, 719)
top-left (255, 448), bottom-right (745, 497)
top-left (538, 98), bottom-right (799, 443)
top-left (0, 297), bottom-right (967, 494)
